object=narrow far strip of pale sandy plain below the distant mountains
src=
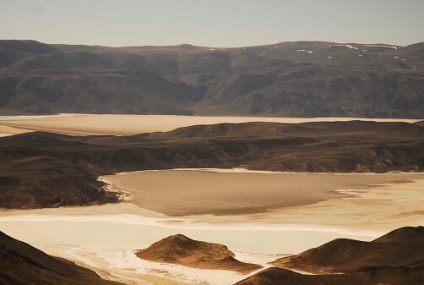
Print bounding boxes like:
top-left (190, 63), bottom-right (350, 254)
top-left (0, 114), bottom-right (419, 135)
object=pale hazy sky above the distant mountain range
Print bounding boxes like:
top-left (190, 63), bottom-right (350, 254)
top-left (0, 0), bottom-right (424, 47)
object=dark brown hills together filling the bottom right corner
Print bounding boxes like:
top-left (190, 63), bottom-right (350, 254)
top-left (237, 227), bottom-right (424, 285)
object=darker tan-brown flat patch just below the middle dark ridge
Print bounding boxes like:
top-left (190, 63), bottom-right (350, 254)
top-left (101, 169), bottom-right (424, 216)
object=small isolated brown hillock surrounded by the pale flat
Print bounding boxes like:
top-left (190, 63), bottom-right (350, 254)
top-left (136, 234), bottom-right (261, 273)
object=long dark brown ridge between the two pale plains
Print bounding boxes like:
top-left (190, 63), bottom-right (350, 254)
top-left (0, 121), bottom-right (424, 208)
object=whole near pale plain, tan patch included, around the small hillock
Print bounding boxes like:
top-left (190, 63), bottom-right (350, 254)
top-left (0, 169), bottom-right (424, 284)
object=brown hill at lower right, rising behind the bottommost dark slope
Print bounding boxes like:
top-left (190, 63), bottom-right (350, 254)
top-left (273, 227), bottom-right (424, 273)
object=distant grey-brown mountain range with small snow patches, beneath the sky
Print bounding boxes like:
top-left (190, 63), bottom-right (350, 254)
top-left (0, 41), bottom-right (424, 118)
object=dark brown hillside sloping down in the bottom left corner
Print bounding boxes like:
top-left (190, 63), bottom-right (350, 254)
top-left (0, 232), bottom-right (120, 285)
